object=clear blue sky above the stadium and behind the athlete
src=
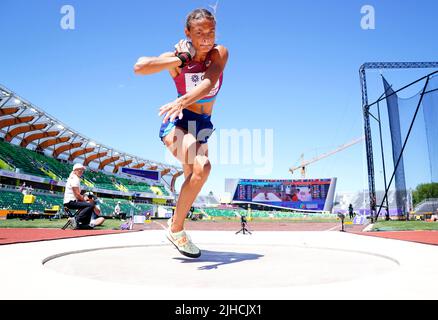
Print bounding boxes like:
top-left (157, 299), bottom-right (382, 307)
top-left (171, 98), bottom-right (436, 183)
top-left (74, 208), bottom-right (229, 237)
top-left (0, 0), bottom-right (438, 194)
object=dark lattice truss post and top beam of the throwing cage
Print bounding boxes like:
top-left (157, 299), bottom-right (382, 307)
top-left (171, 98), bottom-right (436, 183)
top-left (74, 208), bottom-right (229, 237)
top-left (359, 62), bottom-right (438, 222)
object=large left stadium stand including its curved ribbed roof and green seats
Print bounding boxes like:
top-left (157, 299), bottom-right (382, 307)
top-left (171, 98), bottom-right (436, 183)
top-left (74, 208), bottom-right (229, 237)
top-left (0, 85), bottom-right (219, 216)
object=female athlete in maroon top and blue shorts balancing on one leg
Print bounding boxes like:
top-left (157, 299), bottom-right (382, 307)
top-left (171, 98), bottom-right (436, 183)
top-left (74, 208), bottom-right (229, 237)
top-left (134, 9), bottom-right (228, 258)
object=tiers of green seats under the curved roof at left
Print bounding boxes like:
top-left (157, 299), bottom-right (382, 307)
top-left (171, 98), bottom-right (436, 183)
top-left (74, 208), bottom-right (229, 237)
top-left (0, 140), bottom-right (180, 217)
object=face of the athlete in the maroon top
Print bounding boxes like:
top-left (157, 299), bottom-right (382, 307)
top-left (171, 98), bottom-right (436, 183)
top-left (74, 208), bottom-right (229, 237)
top-left (186, 19), bottom-right (216, 53)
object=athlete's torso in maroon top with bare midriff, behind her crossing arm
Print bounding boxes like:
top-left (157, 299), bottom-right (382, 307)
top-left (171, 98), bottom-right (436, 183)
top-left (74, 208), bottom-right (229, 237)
top-left (173, 51), bottom-right (223, 115)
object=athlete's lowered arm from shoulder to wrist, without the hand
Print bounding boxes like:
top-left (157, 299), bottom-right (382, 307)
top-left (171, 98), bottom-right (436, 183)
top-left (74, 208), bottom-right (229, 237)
top-left (182, 46), bottom-right (228, 106)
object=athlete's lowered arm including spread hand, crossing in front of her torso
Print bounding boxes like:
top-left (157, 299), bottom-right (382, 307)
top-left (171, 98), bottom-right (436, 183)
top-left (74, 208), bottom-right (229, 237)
top-left (159, 46), bottom-right (228, 123)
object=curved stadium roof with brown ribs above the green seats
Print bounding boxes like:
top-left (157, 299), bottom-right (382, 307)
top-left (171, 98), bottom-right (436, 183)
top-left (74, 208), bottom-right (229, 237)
top-left (0, 85), bottom-right (182, 177)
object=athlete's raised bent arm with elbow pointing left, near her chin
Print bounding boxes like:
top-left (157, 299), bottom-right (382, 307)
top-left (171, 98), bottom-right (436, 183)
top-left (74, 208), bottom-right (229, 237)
top-left (134, 52), bottom-right (182, 77)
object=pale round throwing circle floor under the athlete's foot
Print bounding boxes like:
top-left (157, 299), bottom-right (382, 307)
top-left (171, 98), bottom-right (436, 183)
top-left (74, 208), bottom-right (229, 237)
top-left (43, 245), bottom-right (399, 288)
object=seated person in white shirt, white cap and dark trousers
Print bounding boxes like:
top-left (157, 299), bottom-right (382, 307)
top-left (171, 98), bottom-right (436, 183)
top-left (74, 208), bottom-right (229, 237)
top-left (64, 163), bottom-right (95, 229)
